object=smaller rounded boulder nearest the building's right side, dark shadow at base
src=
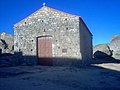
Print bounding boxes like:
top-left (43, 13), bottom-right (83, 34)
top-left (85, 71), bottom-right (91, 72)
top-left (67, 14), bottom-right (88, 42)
top-left (93, 44), bottom-right (112, 58)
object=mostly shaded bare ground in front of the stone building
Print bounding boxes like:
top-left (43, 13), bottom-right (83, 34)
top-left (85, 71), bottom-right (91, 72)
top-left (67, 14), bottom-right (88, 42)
top-left (0, 63), bottom-right (120, 90)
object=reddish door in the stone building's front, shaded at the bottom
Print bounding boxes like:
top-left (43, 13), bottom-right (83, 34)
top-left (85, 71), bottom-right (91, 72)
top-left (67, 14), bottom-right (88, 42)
top-left (37, 37), bottom-right (52, 65)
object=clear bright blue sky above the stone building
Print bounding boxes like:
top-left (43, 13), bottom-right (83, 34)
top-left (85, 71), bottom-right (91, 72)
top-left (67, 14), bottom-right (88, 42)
top-left (0, 0), bottom-right (120, 45)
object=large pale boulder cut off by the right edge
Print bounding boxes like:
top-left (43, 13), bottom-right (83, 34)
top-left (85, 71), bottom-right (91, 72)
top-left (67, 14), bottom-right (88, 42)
top-left (109, 35), bottom-right (120, 59)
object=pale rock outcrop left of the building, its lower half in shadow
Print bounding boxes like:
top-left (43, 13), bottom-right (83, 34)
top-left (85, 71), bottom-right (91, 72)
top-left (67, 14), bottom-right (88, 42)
top-left (0, 32), bottom-right (15, 67)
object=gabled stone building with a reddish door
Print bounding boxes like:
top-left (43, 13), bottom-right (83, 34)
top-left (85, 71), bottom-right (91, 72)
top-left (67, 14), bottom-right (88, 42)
top-left (14, 5), bottom-right (92, 66)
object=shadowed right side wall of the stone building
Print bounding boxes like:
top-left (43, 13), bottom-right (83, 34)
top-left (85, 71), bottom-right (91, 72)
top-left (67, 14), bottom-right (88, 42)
top-left (80, 19), bottom-right (93, 64)
